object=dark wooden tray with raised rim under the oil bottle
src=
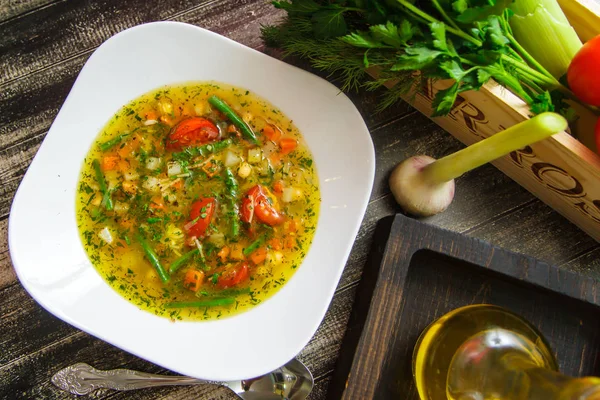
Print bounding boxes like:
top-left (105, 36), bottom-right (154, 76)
top-left (329, 215), bottom-right (600, 400)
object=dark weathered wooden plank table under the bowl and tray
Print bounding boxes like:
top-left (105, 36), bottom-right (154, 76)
top-left (0, 0), bottom-right (600, 399)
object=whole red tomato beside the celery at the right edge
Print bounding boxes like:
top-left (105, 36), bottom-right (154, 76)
top-left (567, 35), bottom-right (600, 106)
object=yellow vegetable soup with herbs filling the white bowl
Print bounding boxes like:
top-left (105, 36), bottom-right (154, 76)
top-left (77, 83), bottom-right (320, 320)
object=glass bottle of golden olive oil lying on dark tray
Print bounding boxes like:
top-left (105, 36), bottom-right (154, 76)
top-left (413, 304), bottom-right (600, 400)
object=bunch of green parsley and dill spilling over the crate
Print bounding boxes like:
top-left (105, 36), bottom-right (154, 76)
top-left (262, 0), bottom-right (576, 119)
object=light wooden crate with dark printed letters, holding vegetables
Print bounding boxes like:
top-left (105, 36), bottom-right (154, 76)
top-left (376, 0), bottom-right (600, 241)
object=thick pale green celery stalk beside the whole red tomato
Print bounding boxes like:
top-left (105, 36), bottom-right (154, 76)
top-left (510, 0), bottom-right (582, 79)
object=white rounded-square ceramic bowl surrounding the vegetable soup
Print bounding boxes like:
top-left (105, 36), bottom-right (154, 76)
top-left (9, 22), bottom-right (375, 380)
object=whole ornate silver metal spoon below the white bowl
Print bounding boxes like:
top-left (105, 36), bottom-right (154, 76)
top-left (51, 358), bottom-right (314, 400)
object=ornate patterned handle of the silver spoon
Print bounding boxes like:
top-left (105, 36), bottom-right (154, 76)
top-left (51, 363), bottom-right (223, 395)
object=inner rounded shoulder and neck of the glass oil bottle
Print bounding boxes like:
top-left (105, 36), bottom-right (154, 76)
top-left (446, 328), bottom-right (600, 400)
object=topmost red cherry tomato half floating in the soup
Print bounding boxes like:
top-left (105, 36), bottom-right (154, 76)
top-left (167, 117), bottom-right (219, 150)
